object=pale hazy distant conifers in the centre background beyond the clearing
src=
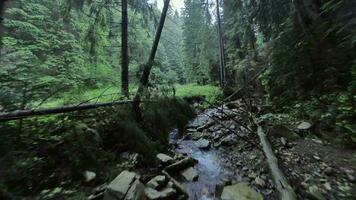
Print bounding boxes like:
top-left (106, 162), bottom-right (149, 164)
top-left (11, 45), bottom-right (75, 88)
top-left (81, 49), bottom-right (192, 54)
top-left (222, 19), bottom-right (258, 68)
top-left (183, 0), bottom-right (219, 85)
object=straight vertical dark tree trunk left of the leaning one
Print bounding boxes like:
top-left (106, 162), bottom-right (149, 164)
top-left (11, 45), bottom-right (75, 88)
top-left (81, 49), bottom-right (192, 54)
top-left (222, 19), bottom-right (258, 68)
top-left (121, 0), bottom-right (129, 97)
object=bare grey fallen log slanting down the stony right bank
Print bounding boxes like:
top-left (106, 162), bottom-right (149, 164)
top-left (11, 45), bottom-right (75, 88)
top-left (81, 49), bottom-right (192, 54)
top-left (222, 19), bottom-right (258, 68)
top-left (256, 123), bottom-right (297, 200)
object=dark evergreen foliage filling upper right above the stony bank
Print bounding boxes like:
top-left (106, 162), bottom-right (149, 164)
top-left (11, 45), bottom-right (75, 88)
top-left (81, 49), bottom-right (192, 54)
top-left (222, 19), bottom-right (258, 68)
top-left (224, 0), bottom-right (356, 142)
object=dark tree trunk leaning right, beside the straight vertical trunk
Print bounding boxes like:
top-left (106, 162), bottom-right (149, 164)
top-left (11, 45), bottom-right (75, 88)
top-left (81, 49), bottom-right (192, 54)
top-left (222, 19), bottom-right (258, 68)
top-left (134, 0), bottom-right (170, 121)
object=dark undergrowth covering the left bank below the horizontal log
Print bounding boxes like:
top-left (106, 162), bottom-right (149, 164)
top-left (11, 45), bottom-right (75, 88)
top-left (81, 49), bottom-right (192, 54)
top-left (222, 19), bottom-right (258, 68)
top-left (0, 98), bottom-right (194, 199)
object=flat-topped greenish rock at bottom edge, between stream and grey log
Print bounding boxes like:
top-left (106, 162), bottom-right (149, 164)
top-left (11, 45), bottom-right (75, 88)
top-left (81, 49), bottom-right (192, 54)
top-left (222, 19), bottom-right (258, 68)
top-left (221, 183), bottom-right (263, 200)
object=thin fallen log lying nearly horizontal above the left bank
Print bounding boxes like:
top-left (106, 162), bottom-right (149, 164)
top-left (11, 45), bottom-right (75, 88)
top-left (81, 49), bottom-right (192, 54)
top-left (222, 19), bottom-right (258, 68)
top-left (0, 100), bottom-right (133, 122)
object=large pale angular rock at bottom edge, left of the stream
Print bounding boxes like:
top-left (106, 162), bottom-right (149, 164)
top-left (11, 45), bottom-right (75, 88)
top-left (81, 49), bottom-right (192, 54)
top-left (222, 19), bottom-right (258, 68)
top-left (104, 170), bottom-right (137, 200)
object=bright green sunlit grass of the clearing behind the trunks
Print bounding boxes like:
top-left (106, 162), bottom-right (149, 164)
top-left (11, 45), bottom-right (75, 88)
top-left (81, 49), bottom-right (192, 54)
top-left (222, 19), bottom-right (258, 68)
top-left (37, 84), bottom-right (219, 108)
